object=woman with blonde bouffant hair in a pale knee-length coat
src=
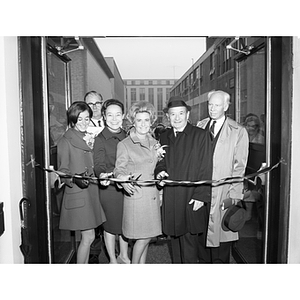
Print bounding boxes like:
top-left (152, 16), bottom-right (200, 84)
top-left (114, 101), bottom-right (162, 263)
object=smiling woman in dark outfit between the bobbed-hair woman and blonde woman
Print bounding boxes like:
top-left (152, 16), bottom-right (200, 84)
top-left (94, 99), bottom-right (130, 264)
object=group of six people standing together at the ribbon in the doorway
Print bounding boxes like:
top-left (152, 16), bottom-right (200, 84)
top-left (58, 91), bottom-right (249, 264)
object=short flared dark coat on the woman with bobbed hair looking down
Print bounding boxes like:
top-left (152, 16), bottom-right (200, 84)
top-left (57, 128), bottom-right (106, 230)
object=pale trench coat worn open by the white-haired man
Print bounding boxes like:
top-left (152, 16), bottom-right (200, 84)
top-left (197, 117), bottom-right (249, 247)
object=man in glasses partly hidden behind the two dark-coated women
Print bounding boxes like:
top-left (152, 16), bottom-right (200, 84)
top-left (84, 91), bottom-right (104, 136)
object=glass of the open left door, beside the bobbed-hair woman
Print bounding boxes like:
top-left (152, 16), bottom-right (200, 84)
top-left (47, 49), bottom-right (75, 263)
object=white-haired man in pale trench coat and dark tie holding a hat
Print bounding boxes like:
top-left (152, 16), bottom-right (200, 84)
top-left (197, 91), bottom-right (249, 263)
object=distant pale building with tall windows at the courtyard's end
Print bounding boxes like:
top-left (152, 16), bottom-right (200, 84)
top-left (124, 79), bottom-right (176, 123)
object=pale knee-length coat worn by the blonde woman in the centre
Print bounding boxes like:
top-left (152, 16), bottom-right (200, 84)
top-left (114, 129), bottom-right (162, 239)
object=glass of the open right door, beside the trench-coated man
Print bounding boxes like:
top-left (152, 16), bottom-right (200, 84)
top-left (233, 47), bottom-right (266, 263)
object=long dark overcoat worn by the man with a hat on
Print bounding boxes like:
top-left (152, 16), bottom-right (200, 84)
top-left (155, 123), bottom-right (211, 236)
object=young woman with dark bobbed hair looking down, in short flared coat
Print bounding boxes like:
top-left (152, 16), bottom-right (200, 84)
top-left (57, 101), bottom-right (106, 263)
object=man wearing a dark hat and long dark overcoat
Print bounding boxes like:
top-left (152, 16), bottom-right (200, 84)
top-left (155, 96), bottom-right (212, 263)
